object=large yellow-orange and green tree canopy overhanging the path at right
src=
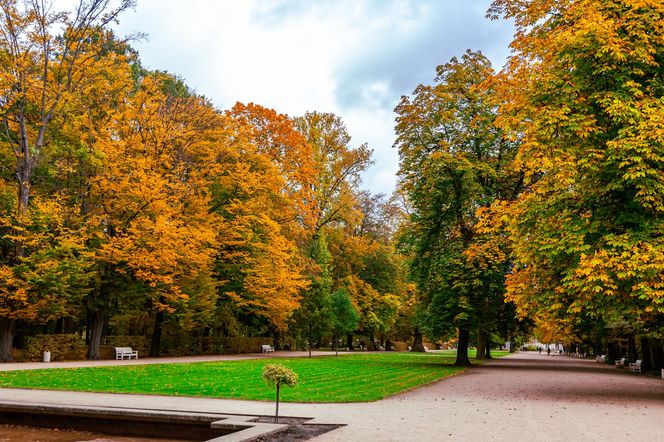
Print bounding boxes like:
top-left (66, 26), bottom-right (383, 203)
top-left (489, 0), bottom-right (664, 356)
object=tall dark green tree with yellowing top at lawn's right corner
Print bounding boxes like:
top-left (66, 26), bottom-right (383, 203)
top-left (395, 51), bottom-right (519, 365)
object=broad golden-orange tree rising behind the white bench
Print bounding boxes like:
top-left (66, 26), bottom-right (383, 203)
top-left (83, 73), bottom-right (221, 359)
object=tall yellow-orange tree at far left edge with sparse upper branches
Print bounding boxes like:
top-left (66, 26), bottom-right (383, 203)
top-left (0, 0), bottom-right (133, 361)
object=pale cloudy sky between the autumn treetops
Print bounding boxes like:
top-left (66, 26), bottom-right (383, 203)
top-left (109, 0), bottom-right (513, 195)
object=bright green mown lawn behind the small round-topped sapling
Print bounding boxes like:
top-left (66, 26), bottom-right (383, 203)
top-left (0, 352), bottom-right (508, 402)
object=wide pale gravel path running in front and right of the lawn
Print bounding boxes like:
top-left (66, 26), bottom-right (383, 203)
top-left (0, 353), bottom-right (664, 442)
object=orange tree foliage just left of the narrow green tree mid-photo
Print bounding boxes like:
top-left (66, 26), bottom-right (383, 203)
top-left (217, 103), bottom-right (313, 333)
